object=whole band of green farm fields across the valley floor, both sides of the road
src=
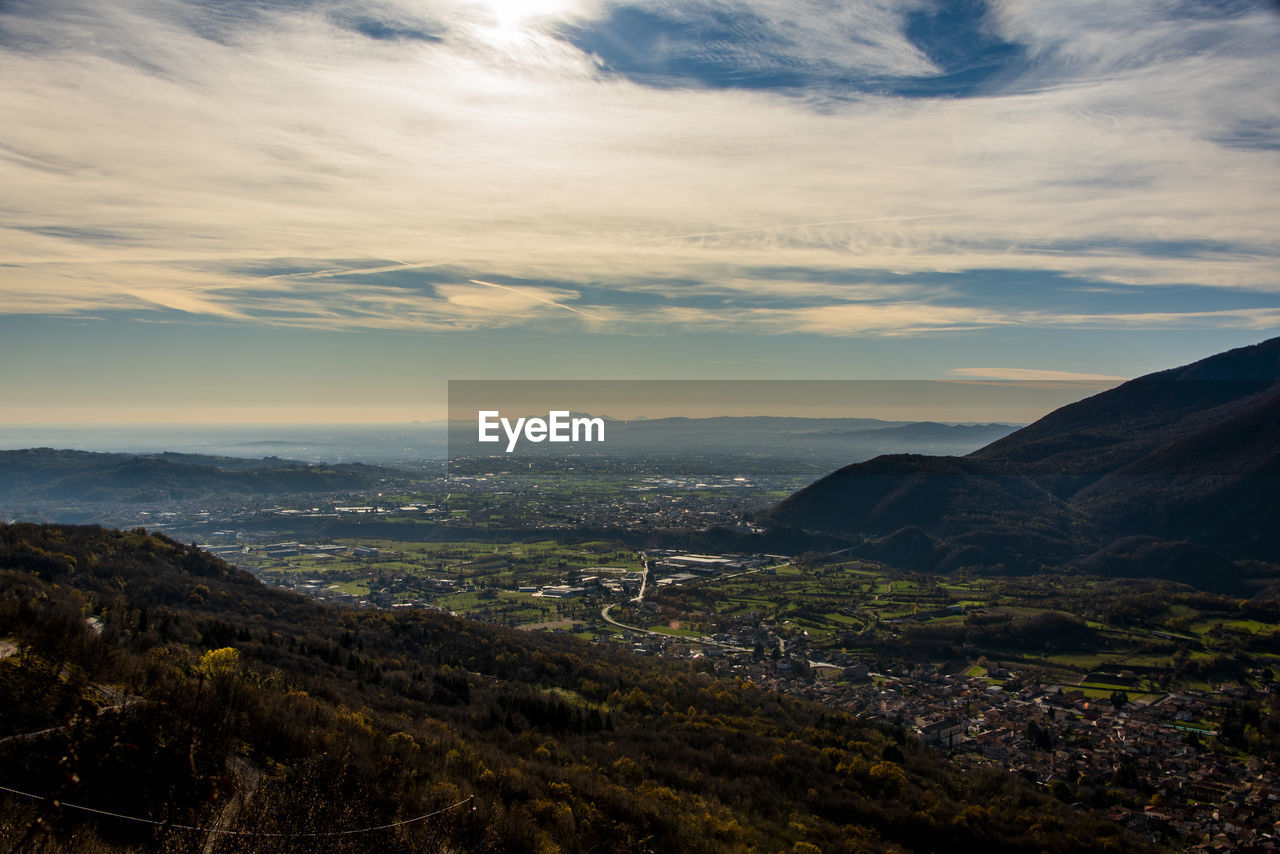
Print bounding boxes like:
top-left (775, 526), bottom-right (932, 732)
top-left (237, 539), bottom-right (1280, 700)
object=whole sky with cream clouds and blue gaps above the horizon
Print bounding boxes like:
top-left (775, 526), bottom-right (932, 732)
top-left (0, 0), bottom-right (1280, 425)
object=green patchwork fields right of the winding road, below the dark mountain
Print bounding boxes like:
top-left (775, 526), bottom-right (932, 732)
top-left (645, 558), bottom-right (1280, 699)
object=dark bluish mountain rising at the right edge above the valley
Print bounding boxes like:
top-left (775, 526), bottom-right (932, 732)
top-left (760, 338), bottom-right (1280, 588)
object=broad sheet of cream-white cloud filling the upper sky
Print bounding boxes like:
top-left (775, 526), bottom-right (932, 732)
top-left (0, 0), bottom-right (1280, 335)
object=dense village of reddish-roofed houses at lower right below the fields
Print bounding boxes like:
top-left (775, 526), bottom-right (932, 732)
top-left (762, 663), bottom-right (1280, 851)
